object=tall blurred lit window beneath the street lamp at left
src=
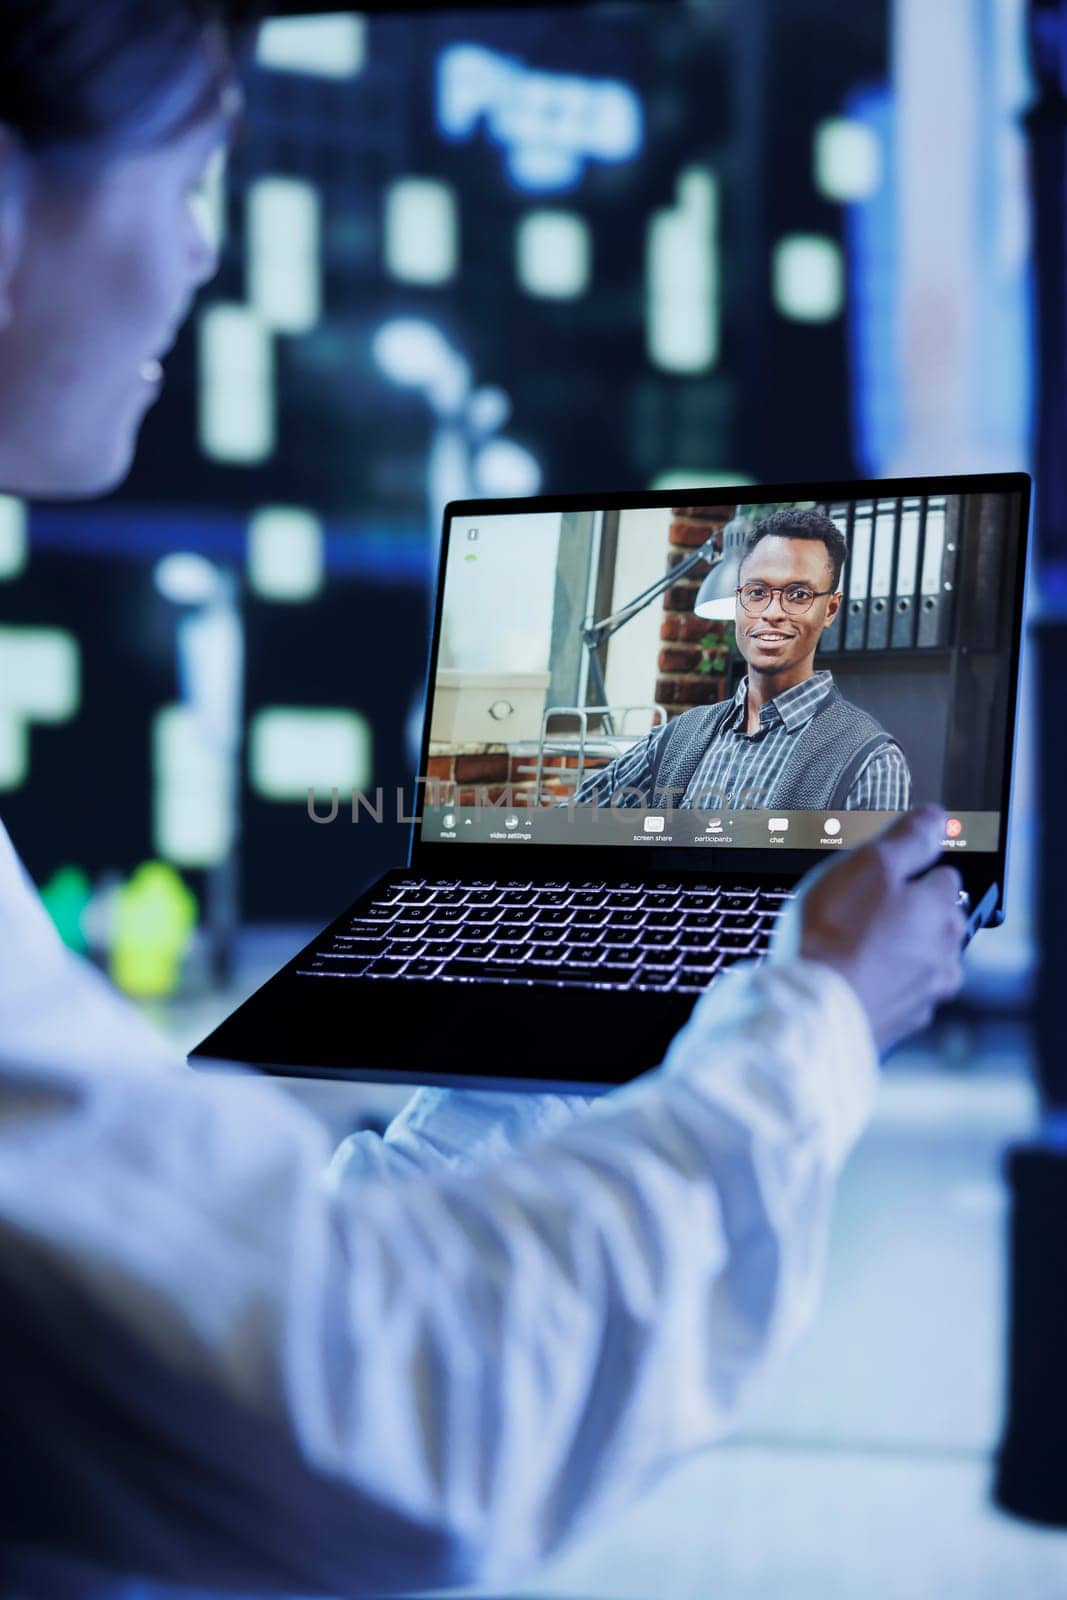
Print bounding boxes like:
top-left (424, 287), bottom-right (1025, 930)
top-left (152, 706), bottom-right (235, 867)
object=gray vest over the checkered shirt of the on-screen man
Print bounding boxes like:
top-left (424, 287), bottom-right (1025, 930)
top-left (651, 685), bottom-right (899, 811)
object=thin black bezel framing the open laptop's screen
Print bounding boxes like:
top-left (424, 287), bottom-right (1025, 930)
top-left (408, 472), bottom-right (1032, 922)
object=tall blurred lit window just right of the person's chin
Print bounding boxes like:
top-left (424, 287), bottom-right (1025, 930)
top-left (200, 306), bottom-right (275, 462)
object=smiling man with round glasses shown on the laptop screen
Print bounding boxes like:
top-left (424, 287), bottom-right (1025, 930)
top-left (573, 507), bottom-right (912, 811)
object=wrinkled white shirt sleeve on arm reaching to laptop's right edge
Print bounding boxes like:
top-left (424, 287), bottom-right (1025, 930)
top-left (0, 902), bottom-right (877, 1594)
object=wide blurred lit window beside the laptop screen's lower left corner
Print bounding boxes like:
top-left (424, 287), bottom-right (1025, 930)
top-left (250, 706), bottom-right (371, 802)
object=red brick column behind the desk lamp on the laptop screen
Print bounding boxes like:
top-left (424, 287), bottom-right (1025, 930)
top-left (656, 506), bottom-right (736, 718)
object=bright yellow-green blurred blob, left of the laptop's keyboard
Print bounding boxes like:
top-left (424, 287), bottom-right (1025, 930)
top-left (110, 861), bottom-right (200, 1000)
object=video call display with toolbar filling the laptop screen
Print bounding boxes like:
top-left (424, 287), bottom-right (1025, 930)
top-left (421, 485), bottom-right (1022, 853)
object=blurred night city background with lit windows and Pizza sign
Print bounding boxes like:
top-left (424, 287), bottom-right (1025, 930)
top-left (0, 0), bottom-right (1067, 1600)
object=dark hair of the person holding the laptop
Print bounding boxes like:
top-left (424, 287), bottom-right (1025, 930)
top-left (0, 0), bottom-right (254, 154)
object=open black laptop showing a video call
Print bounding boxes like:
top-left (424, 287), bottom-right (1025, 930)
top-left (190, 474), bottom-right (1030, 1093)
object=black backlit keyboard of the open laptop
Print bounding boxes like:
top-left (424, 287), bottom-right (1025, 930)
top-left (296, 878), bottom-right (793, 994)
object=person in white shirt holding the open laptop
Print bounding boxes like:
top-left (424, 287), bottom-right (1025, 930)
top-left (0, 0), bottom-right (963, 1595)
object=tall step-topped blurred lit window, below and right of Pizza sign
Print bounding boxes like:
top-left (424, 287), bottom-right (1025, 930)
top-left (646, 168), bottom-right (718, 373)
